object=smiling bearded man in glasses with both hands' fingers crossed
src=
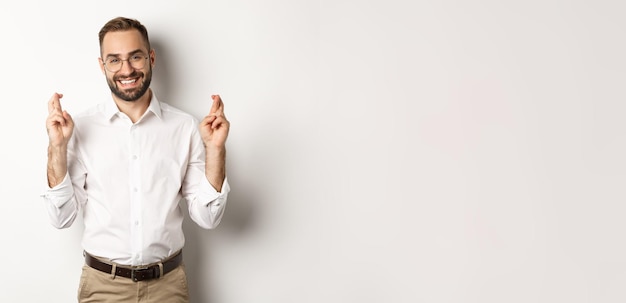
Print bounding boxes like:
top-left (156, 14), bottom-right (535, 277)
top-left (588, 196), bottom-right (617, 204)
top-left (43, 17), bottom-right (230, 302)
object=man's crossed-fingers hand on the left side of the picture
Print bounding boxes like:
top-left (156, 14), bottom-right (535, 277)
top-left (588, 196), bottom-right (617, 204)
top-left (46, 93), bottom-right (74, 148)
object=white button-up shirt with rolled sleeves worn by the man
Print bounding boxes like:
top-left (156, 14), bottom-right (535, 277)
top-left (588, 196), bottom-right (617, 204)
top-left (42, 94), bottom-right (230, 265)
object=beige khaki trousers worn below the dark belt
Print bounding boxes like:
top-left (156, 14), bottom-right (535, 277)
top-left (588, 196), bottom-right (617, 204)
top-left (78, 264), bottom-right (189, 303)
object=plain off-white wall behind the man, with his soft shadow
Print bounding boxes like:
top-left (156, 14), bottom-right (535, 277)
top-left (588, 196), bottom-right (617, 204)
top-left (0, 0), bottom-right (626, 303)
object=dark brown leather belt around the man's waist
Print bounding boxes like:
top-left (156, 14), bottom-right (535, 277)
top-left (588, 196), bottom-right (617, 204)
top-left (85, 251), bottom-right (183, 282)
